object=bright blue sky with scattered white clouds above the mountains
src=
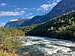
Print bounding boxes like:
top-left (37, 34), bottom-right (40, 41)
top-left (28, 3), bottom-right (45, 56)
top-left (0, 0), bottom-right (61, 25)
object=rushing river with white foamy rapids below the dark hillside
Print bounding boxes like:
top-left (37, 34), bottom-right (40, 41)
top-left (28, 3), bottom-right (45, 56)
top-left (18, 36), bottom-right (75, 56)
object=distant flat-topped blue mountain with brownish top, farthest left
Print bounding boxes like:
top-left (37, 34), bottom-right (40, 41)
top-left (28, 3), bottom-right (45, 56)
top-left (4, 19), bottom-right (30, 28)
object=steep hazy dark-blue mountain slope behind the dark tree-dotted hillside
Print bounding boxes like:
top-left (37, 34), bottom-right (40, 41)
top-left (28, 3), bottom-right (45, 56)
top-left (32, 0), bottom-right (75, 23)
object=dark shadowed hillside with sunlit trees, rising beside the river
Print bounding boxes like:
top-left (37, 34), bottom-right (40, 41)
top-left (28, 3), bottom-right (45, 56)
top-left (27, 12), bottom-right (75, 40)
